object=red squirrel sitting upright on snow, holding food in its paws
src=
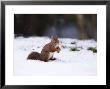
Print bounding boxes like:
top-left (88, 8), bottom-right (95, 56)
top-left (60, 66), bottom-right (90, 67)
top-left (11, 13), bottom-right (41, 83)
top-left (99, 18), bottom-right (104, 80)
top-left (27, 36), bottom-right (61, 62)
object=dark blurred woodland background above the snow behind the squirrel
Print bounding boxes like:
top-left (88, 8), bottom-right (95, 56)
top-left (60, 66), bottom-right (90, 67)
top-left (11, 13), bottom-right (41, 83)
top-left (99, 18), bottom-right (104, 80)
top-left (14, 14), bottom-right (97, 39)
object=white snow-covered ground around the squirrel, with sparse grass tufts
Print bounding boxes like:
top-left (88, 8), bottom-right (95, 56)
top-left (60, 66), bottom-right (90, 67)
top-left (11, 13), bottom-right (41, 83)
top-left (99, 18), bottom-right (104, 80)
top-left (13, 37), bottom-right (97, 76)
